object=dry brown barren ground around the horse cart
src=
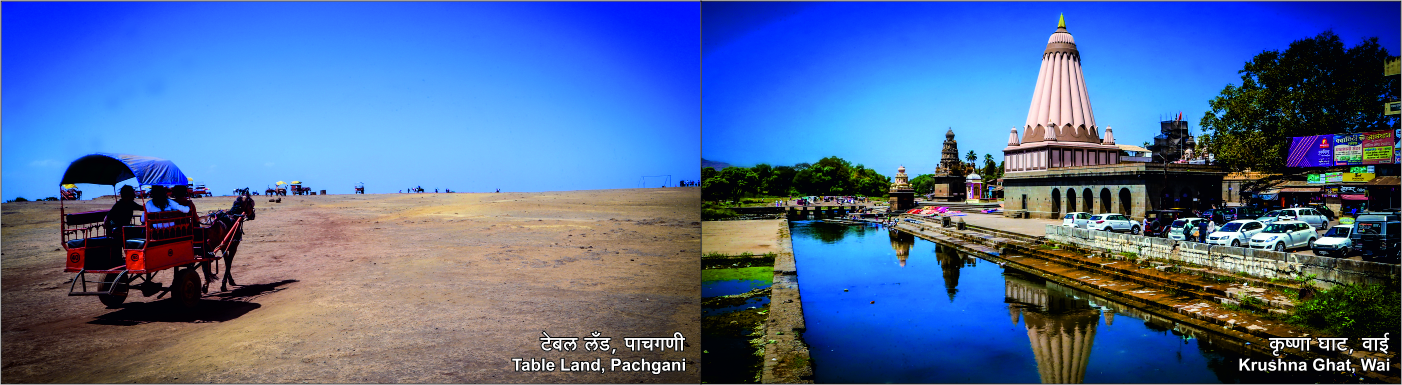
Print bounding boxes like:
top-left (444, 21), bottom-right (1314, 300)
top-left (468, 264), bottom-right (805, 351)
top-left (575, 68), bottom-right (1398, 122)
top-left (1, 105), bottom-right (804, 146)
top-left (0, 188), bottom-right (701, 384)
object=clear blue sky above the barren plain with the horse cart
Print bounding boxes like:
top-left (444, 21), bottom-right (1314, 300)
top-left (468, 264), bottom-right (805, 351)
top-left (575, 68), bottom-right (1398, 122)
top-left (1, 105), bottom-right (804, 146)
top-left (0, 1), bottom-right (701, 200)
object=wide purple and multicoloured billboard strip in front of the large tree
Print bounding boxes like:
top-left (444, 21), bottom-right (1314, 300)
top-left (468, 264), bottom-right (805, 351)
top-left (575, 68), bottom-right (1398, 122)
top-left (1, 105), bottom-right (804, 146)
top-left (1286, 130), bottom-right (1398, 167)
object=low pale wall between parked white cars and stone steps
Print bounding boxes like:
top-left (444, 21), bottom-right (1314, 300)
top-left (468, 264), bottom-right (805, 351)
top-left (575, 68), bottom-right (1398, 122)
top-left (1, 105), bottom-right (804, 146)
top-left (1046, 224), bottom-right (1402, 288)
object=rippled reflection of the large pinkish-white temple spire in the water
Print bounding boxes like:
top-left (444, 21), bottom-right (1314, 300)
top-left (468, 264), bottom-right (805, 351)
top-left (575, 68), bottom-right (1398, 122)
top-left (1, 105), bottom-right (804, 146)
top-left (1002, 270), bottom-right (1109, 384)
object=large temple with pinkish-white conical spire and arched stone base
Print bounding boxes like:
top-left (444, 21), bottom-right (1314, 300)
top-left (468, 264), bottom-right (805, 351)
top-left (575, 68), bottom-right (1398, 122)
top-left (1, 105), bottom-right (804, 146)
top-left (1002, 17), bottom-right (1225, 218)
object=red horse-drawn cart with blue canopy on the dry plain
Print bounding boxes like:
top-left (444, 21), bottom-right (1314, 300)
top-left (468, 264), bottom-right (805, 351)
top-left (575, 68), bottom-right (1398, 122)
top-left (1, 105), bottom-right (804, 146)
top-left (59, 154), bottom-right (251, 307)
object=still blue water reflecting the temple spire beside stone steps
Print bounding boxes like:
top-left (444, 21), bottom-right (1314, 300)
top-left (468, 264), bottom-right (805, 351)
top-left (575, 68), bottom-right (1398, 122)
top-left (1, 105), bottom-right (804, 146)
top-left (791, 221), bottom-right (1339, 384)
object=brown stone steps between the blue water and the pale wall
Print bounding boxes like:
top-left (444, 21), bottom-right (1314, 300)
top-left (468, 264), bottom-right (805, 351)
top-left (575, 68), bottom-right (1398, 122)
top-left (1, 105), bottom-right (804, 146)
top-left (896, 216), bottom-right (1399, 384)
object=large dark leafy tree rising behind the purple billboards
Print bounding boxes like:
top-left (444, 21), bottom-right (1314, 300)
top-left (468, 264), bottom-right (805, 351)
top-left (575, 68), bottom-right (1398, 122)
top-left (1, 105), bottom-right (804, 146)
top-left (1199, 31), bottom-right (1398, 172)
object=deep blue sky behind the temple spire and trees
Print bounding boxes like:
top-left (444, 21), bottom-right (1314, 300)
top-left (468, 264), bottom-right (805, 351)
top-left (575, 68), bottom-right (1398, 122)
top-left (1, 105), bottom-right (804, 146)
top-left (701, 1), bottom-right (1402, 176)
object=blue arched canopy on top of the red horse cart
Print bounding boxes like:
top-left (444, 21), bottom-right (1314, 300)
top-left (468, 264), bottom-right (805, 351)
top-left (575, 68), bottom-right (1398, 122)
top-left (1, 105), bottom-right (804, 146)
top-left (60, 153), bottom-right (188, 186)
